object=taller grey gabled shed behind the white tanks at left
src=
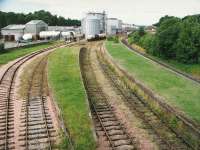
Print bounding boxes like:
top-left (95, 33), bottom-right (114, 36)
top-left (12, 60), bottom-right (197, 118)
top-left (25, 20), bottom-right (48, 39)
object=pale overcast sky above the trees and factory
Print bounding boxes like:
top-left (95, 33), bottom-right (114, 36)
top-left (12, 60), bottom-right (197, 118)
top-left (0, 0), bottom-right (200, 25)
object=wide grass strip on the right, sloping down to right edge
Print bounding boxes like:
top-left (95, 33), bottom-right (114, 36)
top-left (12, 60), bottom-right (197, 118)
top-left (106, 41), bottom-right (200, 123)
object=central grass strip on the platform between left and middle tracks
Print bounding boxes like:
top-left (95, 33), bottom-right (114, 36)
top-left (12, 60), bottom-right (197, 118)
top-left (48, 48), bottom-right (95, 150)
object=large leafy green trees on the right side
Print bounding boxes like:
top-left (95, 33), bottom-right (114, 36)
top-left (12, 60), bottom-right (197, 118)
top-left (129, 15), bottom-right (200, 63)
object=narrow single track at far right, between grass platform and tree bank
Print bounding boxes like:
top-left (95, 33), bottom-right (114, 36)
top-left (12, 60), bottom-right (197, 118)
top-left (121, 39), bottom-right (200, 84)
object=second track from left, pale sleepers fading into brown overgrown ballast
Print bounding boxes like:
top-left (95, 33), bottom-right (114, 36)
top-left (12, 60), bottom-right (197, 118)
top-left (20, 56), bottom-right (55, 149)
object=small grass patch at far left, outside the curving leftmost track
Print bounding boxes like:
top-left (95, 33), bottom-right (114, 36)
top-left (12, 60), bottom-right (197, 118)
top-left (0, 43), bottom-right (54, 66)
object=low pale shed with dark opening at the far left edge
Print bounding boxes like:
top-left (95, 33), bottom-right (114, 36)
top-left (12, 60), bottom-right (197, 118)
top-left (1, 25), bottom-right (25, 41)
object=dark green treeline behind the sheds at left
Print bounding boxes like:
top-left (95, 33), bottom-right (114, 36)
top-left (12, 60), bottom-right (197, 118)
top-left (0, 10), bottom-right (81, 28)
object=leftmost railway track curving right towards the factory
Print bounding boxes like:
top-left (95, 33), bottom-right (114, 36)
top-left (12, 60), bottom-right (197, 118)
top-left (0, 42), bottom-right (61, 150)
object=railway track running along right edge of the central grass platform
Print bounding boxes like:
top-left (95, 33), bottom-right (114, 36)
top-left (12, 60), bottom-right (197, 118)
top-left (80, 48), bottom-right (135, 150)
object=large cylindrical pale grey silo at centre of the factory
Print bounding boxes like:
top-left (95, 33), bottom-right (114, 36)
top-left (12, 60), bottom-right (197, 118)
top-left (85, 16), bottom-right (100, 39)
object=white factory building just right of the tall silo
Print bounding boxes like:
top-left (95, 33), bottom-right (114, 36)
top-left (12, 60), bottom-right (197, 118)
top-left (107, 18), bottom-right (122, 35)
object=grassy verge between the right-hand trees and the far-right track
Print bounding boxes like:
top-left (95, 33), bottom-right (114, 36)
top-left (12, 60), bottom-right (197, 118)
top-left (128, 44), bottom-right (200, 79)
